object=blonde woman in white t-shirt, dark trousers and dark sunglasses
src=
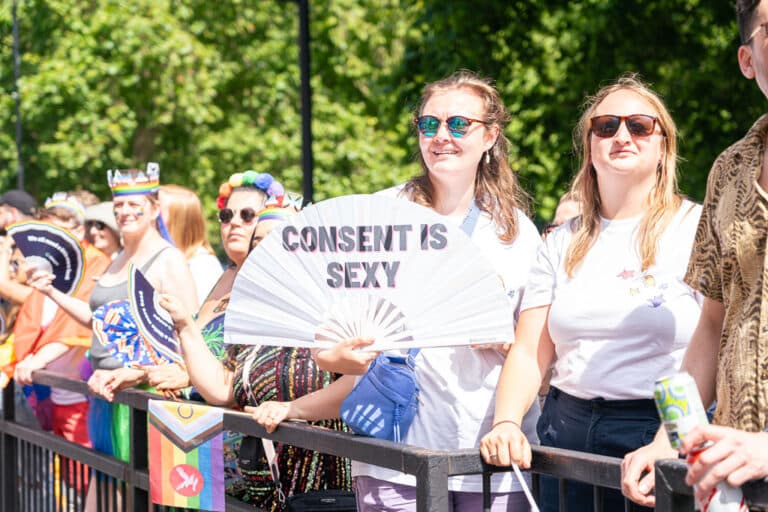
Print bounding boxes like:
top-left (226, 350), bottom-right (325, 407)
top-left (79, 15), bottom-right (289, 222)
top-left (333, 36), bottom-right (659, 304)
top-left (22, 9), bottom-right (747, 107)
top-left (481, 76), bottom-right (701, 511)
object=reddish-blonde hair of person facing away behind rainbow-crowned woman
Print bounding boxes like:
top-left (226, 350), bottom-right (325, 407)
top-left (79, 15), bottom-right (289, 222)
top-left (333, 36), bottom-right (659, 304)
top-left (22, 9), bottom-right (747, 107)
top-left (160, 185), bottom-right (213, 259)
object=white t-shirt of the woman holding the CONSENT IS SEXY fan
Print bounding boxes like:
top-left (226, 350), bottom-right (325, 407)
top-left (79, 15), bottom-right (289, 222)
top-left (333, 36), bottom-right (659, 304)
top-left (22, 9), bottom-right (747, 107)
top-left (352, 189), bottom-right (541, 492)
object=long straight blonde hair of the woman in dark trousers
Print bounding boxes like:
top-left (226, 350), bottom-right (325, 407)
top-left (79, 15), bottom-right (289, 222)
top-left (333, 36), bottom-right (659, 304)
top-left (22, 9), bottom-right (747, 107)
top-left (565, 74), bottom-right (682, 277)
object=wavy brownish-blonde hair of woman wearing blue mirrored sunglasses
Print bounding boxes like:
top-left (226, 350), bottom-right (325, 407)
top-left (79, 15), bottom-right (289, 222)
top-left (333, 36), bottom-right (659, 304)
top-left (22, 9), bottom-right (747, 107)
top-left (405, 70), bottom-right (529, 243)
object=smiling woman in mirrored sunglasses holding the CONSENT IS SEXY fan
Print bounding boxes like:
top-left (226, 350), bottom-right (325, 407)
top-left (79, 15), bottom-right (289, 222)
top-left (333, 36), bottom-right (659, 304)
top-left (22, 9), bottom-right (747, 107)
top-left (253, 71), bottom-right (541, 511)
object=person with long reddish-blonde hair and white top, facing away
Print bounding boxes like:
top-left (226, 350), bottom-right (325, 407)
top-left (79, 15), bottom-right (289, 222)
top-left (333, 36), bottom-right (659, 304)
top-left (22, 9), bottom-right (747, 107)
top-left (160, 185), bottom-right (223, 304)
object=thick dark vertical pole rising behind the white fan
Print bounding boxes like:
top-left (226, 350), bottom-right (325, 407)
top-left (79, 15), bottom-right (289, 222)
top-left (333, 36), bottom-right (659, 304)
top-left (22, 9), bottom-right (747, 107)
top-left (297, 0), bottom-right (315, 203)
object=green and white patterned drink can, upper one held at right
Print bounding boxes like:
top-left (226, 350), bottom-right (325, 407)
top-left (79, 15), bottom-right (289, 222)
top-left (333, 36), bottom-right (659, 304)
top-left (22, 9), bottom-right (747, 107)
top-left (653, 372), bottom-right (709, 450)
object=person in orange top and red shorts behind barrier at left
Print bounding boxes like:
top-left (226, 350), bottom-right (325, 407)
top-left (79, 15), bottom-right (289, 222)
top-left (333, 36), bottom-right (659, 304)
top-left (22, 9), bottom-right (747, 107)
top-left (14, 193), bottom-right (111, 446)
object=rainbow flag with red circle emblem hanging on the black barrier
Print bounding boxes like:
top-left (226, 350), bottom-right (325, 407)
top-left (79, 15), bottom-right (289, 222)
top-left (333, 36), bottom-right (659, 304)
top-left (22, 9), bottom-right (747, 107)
top-left (149, 400), bottom-right (225, 512)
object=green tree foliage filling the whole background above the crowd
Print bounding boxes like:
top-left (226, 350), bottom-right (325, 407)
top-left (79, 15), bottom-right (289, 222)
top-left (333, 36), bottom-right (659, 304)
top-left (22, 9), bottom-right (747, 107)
top-left (0, 0), bottom-right (765, 230)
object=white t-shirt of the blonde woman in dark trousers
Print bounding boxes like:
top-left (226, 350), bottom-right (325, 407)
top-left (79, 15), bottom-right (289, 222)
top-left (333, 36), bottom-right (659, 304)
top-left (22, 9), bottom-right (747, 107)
top-left (522, 201), bottom-right (701, 400)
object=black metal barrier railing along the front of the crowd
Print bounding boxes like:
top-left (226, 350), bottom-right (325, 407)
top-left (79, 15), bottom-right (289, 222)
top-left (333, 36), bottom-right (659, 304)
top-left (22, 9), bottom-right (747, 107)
top-left (0, 371), bottom-right (768, 512)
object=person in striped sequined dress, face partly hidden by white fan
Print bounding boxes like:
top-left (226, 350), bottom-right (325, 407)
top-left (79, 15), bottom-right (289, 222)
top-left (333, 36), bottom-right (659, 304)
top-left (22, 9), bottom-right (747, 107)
top-left (161, 194), bottom-right (350, 511)
